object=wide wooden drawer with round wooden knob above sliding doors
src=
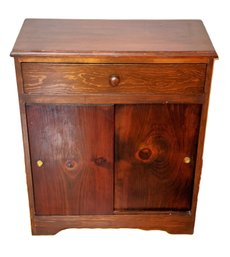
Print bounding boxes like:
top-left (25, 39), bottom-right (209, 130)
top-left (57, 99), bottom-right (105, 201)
top-left (22, 63), bottom-right (206, 95)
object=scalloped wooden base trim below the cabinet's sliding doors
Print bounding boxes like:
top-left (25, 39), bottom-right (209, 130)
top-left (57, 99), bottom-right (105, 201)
top-left (32, 214), bottom-right (194, 235)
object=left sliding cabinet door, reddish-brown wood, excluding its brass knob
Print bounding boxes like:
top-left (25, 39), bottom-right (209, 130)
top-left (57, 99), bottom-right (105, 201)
top-left (26, 105), bottom-right (113, 215)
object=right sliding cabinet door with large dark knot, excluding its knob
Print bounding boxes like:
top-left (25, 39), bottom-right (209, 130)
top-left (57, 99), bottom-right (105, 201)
top-left (115, 104), bottom-right (201, 211)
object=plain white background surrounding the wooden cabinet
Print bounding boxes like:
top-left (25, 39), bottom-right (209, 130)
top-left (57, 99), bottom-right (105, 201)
top-left (0, 0), bottom-right (230, 254)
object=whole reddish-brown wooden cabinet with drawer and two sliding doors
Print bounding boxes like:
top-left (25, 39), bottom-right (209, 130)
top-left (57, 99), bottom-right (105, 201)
top-left (11, 19), bottom-right (217, 234)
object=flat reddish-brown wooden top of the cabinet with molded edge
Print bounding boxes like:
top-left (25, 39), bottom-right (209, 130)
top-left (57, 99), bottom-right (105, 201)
top-left (11, 19), bottom-right (217, 58)
